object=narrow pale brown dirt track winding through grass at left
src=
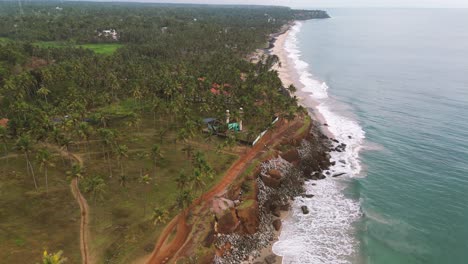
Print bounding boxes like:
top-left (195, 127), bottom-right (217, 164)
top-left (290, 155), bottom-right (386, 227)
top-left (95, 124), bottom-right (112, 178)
top-left (44, 143), bottom-right (93, 264)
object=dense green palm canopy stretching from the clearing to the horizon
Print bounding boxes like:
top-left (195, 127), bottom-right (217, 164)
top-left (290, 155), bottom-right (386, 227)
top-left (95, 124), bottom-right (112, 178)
top-left (0, 1), bottom-right (328, 138)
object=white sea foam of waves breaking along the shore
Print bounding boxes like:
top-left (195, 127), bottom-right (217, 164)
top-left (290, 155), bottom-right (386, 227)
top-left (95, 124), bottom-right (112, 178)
top-left (273, 23), bottom-right (365, 264)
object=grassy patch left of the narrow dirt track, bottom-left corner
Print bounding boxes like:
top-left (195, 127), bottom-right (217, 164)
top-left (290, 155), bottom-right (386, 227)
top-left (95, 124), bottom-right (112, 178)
top-left (0, 156), bottom-right (81, 263)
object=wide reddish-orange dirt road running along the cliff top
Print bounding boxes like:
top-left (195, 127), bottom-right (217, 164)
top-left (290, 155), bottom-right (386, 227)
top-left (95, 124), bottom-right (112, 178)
top-left (146, 120), bottom-right (301, 264)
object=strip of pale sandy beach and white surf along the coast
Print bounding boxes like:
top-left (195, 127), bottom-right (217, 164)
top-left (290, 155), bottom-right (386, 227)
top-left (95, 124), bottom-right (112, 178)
top-left (269, 18), bottom-right (365, 263)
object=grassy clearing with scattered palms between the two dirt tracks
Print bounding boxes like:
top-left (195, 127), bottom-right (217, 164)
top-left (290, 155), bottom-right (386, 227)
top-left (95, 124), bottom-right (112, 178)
top-left (74, 116), bottom-right (237, 263)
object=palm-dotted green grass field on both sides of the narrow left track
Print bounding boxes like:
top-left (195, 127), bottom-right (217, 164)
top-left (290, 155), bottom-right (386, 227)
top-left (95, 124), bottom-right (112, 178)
top-left (0, 108), bottom-right (238, 263)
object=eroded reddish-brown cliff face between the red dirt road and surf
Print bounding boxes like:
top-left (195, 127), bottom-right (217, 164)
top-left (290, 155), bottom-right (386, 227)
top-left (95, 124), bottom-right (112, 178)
top-left (209, 120), bottom-right (330, 263)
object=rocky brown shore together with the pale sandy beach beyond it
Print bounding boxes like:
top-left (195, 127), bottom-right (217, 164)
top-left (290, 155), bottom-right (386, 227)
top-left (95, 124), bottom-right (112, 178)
top-left (210, 17), bottom-right (334, 264)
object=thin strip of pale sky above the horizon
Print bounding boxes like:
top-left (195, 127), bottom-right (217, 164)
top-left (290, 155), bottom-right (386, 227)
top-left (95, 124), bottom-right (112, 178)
top-left (86, 0), bottom-right (468, 8)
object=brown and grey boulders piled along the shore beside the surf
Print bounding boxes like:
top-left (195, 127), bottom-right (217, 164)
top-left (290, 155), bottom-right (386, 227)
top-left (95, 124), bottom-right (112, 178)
top-left (214, 128), bottom-right (330, 264)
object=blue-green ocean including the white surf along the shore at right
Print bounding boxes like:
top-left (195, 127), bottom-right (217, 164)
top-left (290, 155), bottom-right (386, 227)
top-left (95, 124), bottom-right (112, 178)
top-left (273, 9), bottom-right (468, 264)
